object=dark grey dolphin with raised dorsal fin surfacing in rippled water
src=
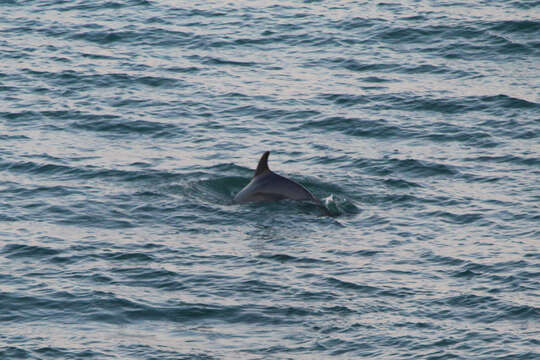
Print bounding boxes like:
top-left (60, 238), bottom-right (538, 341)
top-left (234, 151), bottom-right (327, 212)
